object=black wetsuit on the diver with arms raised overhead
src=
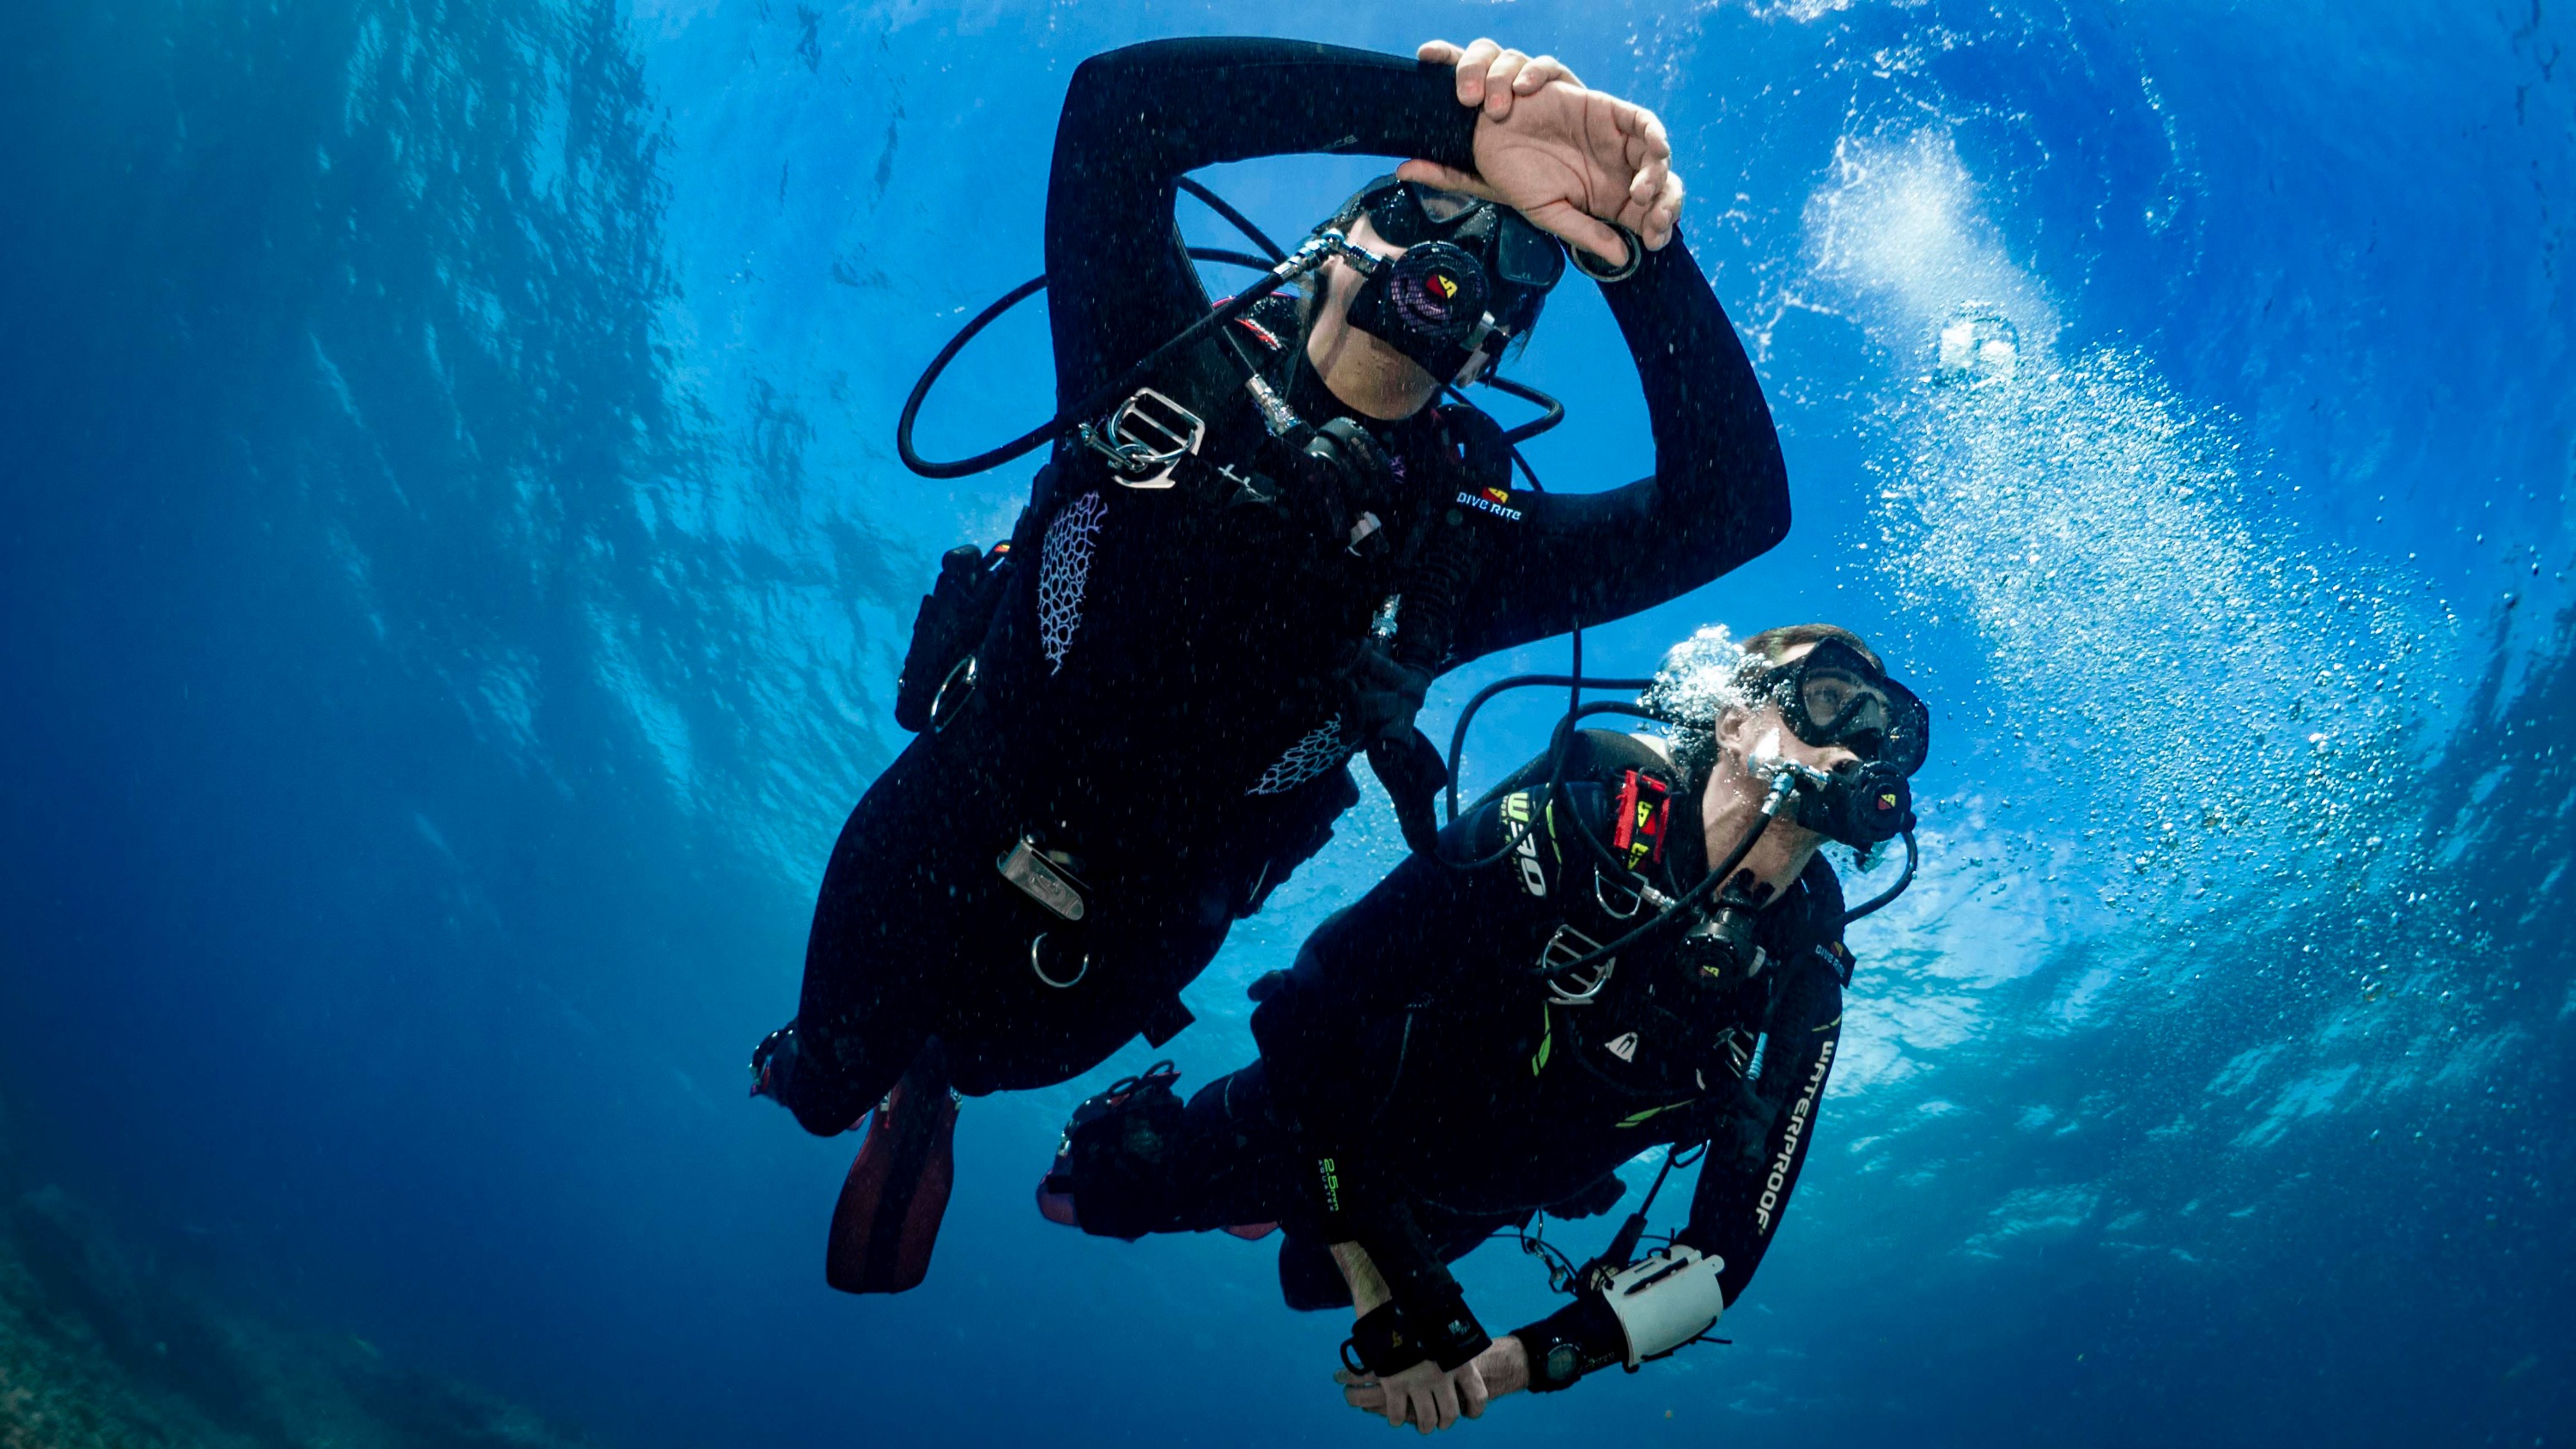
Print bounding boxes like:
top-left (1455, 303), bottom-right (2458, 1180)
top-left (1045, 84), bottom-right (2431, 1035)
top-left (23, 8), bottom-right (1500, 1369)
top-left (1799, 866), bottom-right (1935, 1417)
top-left (775, 39), bottom-right (1788, 1132)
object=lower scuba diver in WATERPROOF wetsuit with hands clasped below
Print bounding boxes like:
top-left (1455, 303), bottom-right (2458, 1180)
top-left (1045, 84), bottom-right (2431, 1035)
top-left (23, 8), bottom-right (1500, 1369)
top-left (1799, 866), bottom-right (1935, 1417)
top-left (1038, 624), bottom-right (1929, 1431)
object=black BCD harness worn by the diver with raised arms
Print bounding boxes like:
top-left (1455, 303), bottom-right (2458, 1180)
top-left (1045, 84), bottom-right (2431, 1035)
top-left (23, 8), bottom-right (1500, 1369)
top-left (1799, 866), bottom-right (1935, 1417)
top-left (896, 299), bottom-right (1517, 1015)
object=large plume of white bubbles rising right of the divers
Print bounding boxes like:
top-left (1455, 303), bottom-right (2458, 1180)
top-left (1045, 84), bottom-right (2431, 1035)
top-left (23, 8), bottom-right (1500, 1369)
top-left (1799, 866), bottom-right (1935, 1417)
top-left (1806, 129), bottom-right (2455, 910)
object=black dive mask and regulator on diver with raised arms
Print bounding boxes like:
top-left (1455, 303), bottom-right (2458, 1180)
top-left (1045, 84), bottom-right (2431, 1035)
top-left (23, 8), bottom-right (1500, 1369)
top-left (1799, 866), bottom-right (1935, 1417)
top-left (1350, 178), bottom-right (1566, 384)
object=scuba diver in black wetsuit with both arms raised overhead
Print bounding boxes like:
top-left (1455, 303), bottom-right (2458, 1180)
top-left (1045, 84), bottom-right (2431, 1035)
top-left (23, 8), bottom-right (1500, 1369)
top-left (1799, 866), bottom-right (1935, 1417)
top-left (752, 39), bottom-right (1788, 1292)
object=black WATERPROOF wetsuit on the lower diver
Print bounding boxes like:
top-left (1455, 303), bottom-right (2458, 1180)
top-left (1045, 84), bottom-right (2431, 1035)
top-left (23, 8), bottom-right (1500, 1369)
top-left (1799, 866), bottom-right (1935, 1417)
top-left (1056, 733), bottom-right (1852, 1387)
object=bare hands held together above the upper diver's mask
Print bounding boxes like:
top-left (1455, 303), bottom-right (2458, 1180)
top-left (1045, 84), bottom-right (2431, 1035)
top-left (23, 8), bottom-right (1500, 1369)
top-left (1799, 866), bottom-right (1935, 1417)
top-left (1396, 41), bottom-right (1682, 265)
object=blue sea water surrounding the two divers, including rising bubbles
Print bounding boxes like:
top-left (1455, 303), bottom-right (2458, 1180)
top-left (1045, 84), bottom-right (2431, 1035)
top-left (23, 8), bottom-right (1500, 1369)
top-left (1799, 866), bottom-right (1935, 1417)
top-left (0, 0), bottom-right (2576, 1446)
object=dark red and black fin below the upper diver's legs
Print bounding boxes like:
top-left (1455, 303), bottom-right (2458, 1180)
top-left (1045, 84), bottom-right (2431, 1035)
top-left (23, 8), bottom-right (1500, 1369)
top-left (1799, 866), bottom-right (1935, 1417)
top-left (822, 1042), bottom-right (958, 1294)
